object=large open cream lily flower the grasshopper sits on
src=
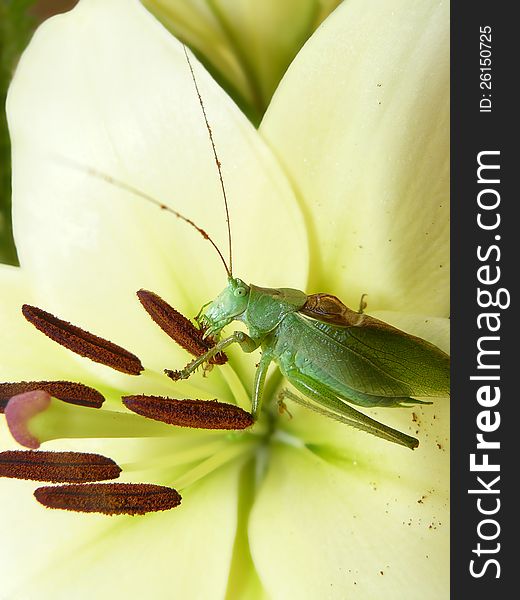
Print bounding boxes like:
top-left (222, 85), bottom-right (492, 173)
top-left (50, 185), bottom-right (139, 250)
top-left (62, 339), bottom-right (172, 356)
top-left (0, 0), bottom-right (449, 600)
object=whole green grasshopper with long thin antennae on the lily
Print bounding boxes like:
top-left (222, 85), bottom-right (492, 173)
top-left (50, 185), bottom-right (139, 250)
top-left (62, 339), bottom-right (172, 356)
top-left (71, 50), bottom-right (449, 449)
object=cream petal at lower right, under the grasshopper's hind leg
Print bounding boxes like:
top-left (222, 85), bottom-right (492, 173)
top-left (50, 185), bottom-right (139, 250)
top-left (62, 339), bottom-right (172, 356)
top-left (250, 312), bottom-right (450, 600)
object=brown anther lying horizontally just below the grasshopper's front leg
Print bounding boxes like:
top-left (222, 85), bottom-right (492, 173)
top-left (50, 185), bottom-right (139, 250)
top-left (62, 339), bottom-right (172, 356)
top-left (123, 395), bottom-right (254, 429)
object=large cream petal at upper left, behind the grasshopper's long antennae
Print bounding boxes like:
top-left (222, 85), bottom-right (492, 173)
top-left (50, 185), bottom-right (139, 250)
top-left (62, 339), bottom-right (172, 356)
top-left (8, 0), bottom-right (308, 385)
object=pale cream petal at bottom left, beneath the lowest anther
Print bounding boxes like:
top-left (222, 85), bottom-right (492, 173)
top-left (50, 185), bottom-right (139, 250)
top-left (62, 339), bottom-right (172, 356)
top-left (0, 436), bottom-right (243, 600)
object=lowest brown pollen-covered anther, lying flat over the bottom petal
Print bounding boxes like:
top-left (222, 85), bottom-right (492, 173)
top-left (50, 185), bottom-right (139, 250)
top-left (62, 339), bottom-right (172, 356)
top-left (34, 483), bottom-right (181, 515)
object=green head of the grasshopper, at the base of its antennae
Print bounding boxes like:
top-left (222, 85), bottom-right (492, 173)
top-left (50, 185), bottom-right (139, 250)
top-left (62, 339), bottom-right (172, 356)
top-left (197, 277), bottom-right (249, 339)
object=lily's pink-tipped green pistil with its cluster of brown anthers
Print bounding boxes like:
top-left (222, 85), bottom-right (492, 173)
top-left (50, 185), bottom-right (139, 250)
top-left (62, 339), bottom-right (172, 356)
top-left (0, 290), bottom-right (290, 515)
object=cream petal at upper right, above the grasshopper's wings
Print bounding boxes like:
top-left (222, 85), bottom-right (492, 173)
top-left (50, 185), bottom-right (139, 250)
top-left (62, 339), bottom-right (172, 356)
top-left (260, 0), bottom-right (449, 316)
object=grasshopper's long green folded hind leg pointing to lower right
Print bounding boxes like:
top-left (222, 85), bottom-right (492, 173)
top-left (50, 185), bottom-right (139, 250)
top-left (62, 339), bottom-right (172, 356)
top-left (280, 369), bottom-right (419, 450)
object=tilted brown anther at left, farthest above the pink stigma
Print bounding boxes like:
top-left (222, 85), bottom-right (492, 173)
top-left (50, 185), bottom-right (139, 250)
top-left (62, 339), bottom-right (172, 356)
top-left (22, 304), bottom-right (143, 375)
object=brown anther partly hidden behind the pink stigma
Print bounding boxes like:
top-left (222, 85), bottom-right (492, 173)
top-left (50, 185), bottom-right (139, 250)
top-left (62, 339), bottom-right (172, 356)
top-left (0, 381), bottom-right (105, 413)
